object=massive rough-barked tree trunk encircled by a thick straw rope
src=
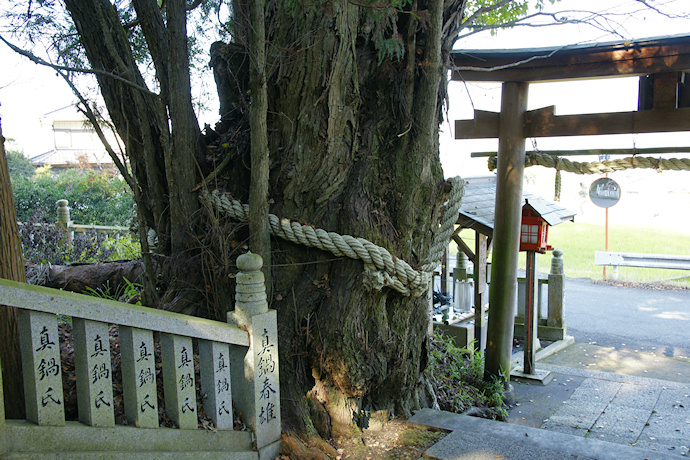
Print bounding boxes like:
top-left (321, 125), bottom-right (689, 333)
top-left (211, 1), bottom-right (462, 431)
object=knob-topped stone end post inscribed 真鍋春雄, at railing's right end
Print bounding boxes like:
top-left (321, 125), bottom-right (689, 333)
top-left (228, 253), bottom-right (281, 459)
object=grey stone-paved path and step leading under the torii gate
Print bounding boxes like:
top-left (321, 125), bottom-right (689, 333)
top-left (410, 344), bottom-right (690, 460)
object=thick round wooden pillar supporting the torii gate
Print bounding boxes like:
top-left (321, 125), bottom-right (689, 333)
top-left (484, 82), bottom-right (529, 384)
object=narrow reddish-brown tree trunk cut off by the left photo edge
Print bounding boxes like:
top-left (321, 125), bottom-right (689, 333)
top-left (0, 116), bottom-right (26, 419)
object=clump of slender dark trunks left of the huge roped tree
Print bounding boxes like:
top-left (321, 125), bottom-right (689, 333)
top-left (65, 0), bottom-right (206, 311)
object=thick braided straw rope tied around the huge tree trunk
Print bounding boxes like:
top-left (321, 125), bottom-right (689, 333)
top-left (201, 177), bottom-right (465, 297)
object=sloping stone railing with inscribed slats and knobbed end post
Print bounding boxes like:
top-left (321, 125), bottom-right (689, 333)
top-left (0, 254), bottom-right (281, 459)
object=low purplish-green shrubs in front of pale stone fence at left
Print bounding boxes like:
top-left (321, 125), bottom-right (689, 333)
top-left (19, 213), bottom-right (141, 265)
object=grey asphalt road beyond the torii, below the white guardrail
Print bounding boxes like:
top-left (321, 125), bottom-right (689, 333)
top-left (564, 278), bottom-right (690, 358)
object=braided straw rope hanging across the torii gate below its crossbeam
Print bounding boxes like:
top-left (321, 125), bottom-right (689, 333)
top-left (489, 152), bottom-right (690, 174)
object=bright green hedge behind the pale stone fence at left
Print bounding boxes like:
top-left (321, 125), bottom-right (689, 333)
top-left (12, 168), bottom-right (134, 226)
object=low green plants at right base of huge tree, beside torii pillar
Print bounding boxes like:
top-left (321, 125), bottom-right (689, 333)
top-left (426, 331), bottom-right (508, 420)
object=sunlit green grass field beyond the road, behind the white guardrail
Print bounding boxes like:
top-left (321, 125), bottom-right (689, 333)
top-left (451, 222), bottom-right (690, 287)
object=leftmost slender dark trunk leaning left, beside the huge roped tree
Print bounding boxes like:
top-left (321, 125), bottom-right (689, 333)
top-left (65, 0), bottom-right (171, 254)
